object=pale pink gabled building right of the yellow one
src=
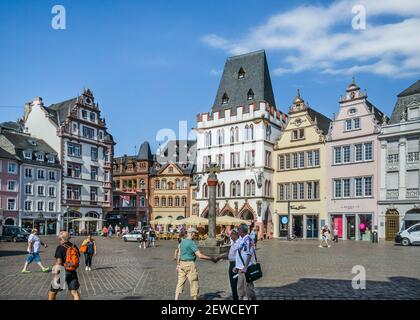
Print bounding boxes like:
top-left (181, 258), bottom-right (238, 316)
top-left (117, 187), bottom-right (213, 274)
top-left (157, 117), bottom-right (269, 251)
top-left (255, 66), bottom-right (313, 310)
top-left (327, 80), bottom-right (386, 241)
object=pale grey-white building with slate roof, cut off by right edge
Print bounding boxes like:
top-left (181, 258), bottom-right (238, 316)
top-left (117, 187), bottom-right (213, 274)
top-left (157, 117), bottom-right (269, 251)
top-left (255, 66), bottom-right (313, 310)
top-left (379, 80), bottom-right (420, 240)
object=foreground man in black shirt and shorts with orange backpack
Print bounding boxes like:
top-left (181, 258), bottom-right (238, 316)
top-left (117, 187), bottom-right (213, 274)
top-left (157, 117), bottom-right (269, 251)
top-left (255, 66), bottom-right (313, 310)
top-left (48, 231), bottom-right (80, 300)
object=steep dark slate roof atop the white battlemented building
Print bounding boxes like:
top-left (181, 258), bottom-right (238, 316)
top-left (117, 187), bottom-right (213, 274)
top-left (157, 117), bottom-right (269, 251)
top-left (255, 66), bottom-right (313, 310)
top-left (212, 50), bottom-right (276, 112)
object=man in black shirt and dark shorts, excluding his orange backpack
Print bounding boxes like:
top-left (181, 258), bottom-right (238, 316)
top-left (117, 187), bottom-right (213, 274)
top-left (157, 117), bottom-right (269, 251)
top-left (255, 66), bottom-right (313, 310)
top-left (48, 231), bottom-right (80, 300)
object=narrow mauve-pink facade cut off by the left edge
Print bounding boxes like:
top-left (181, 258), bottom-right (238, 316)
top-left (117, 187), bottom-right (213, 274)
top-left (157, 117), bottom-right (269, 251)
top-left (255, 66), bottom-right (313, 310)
top-left (0, 148), bottom-right (19, 225)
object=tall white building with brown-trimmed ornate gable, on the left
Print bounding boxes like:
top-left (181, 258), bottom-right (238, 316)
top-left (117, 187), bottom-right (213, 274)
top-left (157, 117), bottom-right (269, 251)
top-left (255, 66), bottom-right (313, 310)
top-left (23, 89), bottom-right (115, 233)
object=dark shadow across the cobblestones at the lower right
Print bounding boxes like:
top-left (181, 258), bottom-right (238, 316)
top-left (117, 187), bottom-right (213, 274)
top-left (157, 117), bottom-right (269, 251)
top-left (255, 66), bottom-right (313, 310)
top-left (255, 277), bottom-right (420, 300)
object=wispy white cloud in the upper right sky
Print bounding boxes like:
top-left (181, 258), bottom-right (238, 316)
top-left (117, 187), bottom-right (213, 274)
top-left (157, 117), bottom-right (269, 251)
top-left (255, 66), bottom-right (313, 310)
top-left (202, 0), bottom-right (420, 77)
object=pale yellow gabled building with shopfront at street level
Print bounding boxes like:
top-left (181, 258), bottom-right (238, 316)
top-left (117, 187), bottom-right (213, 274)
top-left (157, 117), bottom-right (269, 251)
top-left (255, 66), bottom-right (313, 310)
top-left (273, 91), bottom-right (331, 239)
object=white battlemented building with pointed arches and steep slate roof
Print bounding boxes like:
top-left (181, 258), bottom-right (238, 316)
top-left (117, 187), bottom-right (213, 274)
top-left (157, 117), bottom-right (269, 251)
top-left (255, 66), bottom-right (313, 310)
top-left (196, 50), bottom-right (287, 237)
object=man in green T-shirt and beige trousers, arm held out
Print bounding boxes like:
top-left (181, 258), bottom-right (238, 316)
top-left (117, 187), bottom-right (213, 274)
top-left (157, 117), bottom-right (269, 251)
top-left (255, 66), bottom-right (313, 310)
top-left (175, 228), bottom-right (217, 300)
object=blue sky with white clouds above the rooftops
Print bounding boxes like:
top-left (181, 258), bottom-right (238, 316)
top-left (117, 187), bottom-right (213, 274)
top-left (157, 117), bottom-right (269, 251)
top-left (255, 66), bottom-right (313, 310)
top-left (0, 0), bottom-right (420, 156)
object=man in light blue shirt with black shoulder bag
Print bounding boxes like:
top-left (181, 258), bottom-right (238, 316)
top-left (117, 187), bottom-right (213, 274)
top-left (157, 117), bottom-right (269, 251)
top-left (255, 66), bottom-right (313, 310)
top-left (233, 223), bottom-right (257, 300)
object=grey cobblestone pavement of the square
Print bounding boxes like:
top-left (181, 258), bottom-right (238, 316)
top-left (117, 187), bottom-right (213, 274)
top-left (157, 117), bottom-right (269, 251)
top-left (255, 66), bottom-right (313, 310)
top-left (0, 237), bottom-right (420, 300)
